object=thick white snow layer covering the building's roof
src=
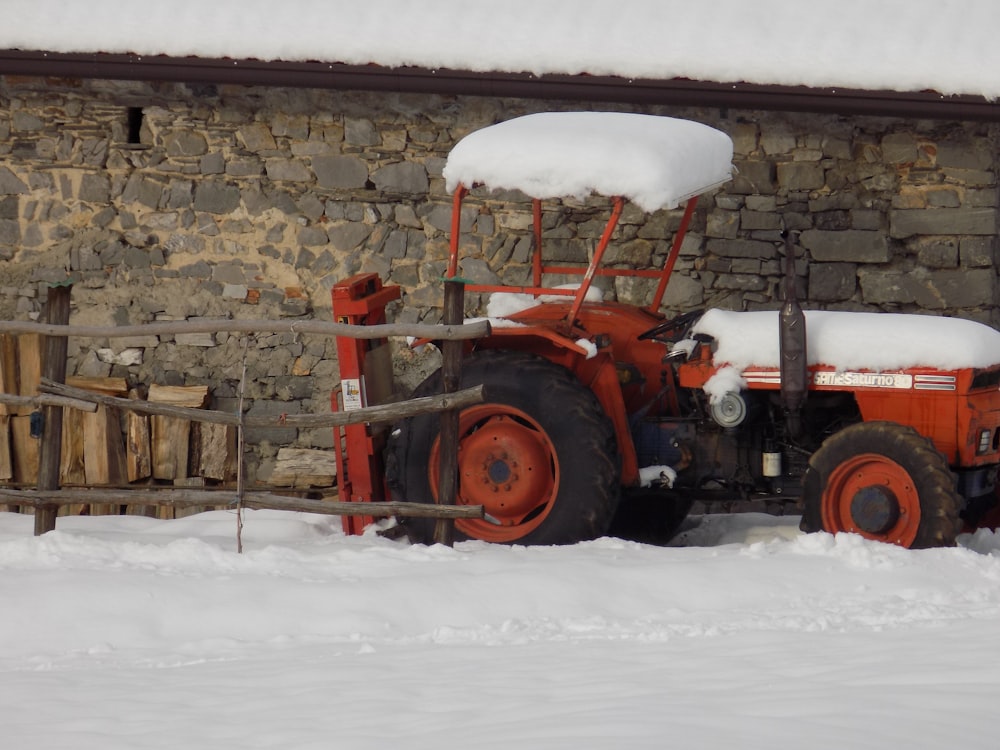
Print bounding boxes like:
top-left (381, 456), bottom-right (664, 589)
top-left (0, 0), bottom-right (1000, 98)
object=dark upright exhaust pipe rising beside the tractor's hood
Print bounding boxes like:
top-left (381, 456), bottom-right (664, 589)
top-left (778, 230), bottom-right (809, 438)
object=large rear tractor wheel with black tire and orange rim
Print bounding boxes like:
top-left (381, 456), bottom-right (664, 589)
top-left (387, 350), bottom-right (621, 544)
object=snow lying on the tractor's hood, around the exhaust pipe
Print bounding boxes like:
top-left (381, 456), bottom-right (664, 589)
top-left (692, 310), bottom-right (1000, 370)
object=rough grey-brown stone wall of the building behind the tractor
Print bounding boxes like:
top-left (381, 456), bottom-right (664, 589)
top-left (0, 77), bottom-right (1000, 478)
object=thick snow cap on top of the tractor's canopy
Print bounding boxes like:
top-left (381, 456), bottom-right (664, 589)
top-left (444, 112), bottom-right (733, 211)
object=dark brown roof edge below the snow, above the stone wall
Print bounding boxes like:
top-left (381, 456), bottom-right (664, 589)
top-left (0, 50), bottom-right (1000, 121)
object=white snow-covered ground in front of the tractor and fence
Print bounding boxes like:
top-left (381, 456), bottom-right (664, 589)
top-left (0, 511), bottom-right (1000, 750)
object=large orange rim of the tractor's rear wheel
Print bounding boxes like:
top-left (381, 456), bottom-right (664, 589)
top-left (427, 404), bottom-right (559, 542)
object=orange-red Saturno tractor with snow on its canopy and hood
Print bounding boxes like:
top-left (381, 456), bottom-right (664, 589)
top-left (344, 113), bottom-right (1000, 547)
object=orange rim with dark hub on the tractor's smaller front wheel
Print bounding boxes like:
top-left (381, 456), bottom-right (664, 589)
top-left (822, 453), bottom-right (920, 547)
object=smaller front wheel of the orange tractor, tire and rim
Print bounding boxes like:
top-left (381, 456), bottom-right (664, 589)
top-left (800, 422), bottom-right (962, 549)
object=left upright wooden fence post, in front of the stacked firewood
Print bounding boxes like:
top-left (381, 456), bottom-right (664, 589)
top-left (35, 282), bottom-right (73, 536)
